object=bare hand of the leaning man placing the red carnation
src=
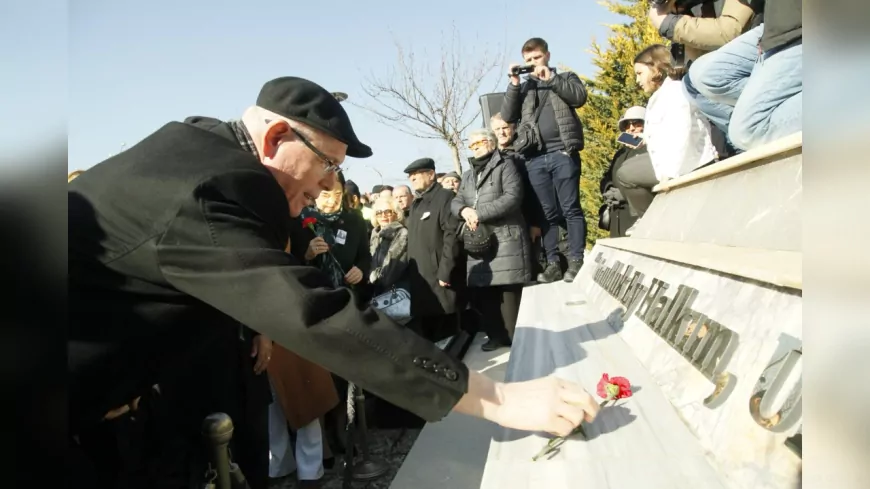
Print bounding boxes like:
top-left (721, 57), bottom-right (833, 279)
top-left (454, 370), bottom-right (599, 436)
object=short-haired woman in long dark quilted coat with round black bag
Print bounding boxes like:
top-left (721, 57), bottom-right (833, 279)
top-left (451, 129), bottom-right (532, 351)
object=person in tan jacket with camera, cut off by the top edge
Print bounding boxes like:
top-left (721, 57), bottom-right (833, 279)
top-left (649, 0), bottom-right (764, 59)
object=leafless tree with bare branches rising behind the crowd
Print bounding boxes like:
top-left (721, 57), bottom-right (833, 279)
top-left (351, 26), bottom-right (504, 172)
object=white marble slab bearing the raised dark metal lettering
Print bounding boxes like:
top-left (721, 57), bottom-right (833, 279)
top-left (574, 248), bottom-right (802, 489)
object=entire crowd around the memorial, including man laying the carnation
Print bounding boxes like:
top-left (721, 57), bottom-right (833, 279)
top-left (69, 0), bottom-right (801, 489)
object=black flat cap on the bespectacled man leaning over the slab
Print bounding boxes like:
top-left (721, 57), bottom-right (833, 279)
top-left (257, 76), bottom-right (372, 158)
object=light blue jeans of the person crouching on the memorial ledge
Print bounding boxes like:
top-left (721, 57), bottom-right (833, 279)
top-left (683, 25), bottom-right (803, 150)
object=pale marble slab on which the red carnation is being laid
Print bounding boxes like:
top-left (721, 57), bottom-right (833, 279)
top-left (469, 282), bottom-right (726, 489)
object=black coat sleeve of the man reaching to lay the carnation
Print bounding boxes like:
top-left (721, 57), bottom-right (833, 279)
top-left (157, 172), bottom-right (468, 421)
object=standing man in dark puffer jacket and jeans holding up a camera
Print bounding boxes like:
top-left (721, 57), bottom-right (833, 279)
top-left (501, 37), bottom-right (586, 283)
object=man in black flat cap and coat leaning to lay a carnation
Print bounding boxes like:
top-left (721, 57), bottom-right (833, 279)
top-left (68, 77), bottom-right (597, 487)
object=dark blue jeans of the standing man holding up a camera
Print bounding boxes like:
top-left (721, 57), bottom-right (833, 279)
top-left (526, 151), bottom-right (586, 263)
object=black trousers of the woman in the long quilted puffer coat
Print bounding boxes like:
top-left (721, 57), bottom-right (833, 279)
top-left (469, 284), bottom-right (523, 343)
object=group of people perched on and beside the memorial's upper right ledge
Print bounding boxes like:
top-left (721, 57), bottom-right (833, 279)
top-left (599, 0), bottom-right (803, 237)
